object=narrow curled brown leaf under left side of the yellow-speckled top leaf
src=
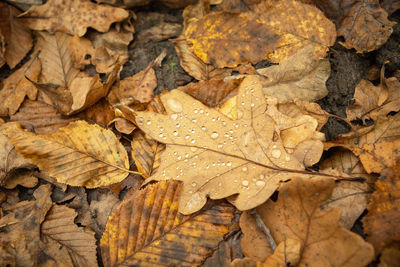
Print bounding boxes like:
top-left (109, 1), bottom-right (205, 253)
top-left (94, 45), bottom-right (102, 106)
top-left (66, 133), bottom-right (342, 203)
top-left (173, 35), bottom-right (232, 81)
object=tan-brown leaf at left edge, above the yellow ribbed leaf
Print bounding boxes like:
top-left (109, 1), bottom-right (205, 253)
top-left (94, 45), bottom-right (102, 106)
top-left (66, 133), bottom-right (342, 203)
top-left (0, 60), bottom-right (41, 116)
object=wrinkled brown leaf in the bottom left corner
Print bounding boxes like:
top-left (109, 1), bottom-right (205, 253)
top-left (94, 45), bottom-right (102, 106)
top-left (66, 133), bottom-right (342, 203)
top-left (0, 184), bottom-right (52, 266)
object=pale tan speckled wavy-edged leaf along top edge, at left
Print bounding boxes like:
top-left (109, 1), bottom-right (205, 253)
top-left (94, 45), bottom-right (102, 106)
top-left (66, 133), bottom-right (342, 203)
top-left (18, 0), bottom-right (129, 37)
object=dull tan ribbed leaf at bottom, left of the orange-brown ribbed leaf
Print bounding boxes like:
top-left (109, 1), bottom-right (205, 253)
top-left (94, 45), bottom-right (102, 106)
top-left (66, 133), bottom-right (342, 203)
top-left (41, 204), bottom-right (97, 266)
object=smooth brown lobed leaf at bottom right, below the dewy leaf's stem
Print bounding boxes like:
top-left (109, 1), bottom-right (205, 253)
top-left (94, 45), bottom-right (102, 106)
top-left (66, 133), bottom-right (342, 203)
top-left (257, 177), bottom-right (374, 267)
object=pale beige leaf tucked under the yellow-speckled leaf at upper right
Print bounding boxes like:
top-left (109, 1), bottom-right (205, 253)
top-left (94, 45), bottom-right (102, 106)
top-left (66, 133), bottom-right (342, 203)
top-left (257, 45), bottom-right (331, 103)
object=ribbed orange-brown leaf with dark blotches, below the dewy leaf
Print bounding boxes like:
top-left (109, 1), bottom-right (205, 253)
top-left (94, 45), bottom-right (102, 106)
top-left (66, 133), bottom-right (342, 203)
top-left (100, 181), bottom-right (234, 266)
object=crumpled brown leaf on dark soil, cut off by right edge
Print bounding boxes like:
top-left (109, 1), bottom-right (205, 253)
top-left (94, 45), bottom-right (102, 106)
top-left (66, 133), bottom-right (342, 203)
top-left (346, 77), bottom-right (400, 121)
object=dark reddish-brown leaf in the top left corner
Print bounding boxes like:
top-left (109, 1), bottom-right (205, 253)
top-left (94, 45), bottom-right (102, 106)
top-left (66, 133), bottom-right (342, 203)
top-left (0, 2), bottom-right (33, 69)
